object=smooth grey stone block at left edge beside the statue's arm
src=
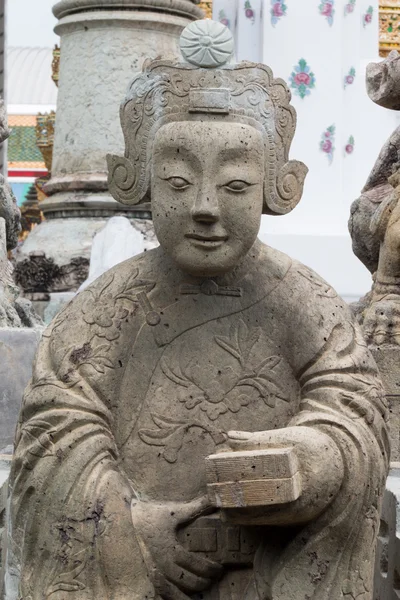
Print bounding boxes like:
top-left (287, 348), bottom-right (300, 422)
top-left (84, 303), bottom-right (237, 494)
top-left (0, 328), bottom-right (40, 454)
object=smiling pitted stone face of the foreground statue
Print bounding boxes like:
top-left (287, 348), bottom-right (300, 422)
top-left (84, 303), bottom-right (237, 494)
top-left (151, 122), bottom-right (264, 277)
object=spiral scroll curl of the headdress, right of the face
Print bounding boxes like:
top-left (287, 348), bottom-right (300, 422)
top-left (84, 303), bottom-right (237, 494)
top-left (263, 160), bottom-right (308, 215)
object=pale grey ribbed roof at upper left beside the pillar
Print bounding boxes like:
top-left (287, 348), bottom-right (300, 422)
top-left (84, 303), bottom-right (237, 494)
top-left (6, 47), bottom-right (57, 105)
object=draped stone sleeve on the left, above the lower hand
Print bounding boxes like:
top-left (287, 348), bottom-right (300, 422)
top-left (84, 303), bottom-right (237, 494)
top-left (7, 280), bottom-right (153, 600)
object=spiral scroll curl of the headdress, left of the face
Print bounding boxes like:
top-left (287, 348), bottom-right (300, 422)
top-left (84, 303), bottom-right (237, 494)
top-left (107, 154), bottom-right (140, 204)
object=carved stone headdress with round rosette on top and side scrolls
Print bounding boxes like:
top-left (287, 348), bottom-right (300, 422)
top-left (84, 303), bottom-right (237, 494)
top-left (107, 20), bottom-right (307, 215)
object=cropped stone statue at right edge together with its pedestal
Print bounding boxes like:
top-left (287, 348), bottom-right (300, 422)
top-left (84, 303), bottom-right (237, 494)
top-left (349, 51), bottom-right (400, 461)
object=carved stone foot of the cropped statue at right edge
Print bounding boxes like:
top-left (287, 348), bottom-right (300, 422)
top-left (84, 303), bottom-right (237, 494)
top-left (363, 294), bottom-right (400, 345)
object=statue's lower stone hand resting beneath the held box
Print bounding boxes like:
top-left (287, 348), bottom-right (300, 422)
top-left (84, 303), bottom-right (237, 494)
top-left (132, 498), bottom-right (222, 600)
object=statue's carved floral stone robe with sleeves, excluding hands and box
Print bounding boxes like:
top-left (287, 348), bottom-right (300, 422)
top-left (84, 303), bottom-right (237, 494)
top-left (9, 243), bottom-right (389, 600)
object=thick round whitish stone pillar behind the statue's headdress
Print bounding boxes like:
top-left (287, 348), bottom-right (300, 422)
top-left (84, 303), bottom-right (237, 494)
top-left (16, 0), bottom-right (203, 308)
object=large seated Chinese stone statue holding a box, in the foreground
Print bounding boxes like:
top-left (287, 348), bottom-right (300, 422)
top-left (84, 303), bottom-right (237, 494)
top-left (8, 21), bottom-right (389, 600)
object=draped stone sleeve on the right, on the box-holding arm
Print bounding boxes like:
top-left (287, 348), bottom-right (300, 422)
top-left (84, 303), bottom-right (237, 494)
top-left (264, 266), bottom-right (390, 600)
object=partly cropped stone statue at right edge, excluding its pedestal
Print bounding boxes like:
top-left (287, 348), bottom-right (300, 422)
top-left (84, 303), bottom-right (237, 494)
top-left (349, 51), bottom-right (400, 324)
